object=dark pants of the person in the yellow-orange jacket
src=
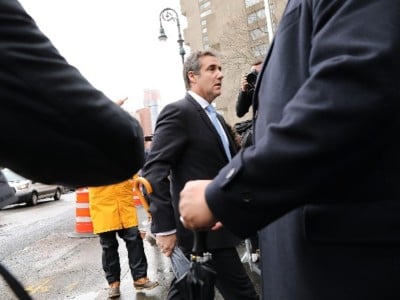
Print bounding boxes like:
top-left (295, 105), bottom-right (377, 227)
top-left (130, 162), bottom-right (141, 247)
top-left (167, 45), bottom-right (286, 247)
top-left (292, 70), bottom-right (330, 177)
top-left (99, 227), bottom-right (147, 283)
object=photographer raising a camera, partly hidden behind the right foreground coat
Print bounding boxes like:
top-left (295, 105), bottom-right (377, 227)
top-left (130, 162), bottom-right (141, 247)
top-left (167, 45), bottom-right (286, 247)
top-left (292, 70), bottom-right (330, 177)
top-left (236, 59), bottom-right (262, 118)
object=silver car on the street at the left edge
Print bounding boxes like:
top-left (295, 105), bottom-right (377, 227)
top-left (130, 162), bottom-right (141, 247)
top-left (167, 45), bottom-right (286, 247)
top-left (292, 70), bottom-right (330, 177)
top-left (1, 168), bottom-right (64, 205)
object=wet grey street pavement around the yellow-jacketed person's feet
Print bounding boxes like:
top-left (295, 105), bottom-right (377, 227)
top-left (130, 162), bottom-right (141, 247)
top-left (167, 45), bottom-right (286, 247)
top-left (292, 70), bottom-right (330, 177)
top-left (0, 193), bottom-right (259, 300)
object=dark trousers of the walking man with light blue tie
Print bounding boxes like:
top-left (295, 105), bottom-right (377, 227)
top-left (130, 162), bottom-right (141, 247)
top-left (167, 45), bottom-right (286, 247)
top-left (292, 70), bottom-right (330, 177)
top-left (168, 248), bottom-right (259, 300)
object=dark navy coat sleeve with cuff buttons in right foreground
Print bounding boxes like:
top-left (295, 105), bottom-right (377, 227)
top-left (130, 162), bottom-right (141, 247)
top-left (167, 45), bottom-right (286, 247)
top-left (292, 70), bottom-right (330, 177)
top-left (206, 0), bottom-right (400, 237)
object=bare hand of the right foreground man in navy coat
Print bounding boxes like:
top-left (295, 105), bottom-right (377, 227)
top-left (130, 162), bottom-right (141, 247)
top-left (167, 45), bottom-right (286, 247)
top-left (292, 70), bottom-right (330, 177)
top-left (179, 180), bottom-right (220, 230)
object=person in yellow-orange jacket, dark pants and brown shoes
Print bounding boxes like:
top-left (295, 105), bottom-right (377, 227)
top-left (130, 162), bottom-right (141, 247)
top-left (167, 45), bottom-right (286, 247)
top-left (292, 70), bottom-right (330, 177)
top-left (89, 179), bottom-right (158, 298)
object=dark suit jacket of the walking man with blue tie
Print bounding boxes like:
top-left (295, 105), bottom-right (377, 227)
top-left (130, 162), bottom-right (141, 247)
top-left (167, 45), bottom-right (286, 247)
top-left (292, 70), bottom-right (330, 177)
top-left (142, 94), bottom-right (239, 251)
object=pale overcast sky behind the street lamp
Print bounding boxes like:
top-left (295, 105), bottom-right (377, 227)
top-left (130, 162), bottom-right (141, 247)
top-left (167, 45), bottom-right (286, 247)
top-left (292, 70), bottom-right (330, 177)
top-left (20, 0), bottom-right (189, 110)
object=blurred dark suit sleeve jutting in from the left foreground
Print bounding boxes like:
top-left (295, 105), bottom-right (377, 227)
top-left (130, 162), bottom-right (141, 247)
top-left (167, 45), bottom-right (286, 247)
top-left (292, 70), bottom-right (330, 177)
top-left (0, 0), bottom-right (144, 186)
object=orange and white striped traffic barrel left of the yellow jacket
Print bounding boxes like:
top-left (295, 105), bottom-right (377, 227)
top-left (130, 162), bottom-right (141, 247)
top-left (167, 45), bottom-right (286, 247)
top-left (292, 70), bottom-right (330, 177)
top-left (68, 188), bottom-right (97, 237)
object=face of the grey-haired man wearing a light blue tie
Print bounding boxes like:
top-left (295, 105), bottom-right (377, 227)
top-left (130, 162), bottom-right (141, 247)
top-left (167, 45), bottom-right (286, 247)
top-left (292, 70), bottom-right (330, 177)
top-left (188, 55), bottom-right (224, 103)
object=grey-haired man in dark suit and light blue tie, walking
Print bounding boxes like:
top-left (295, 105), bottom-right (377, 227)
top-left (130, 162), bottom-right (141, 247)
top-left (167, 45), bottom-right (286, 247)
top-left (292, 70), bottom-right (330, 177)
top-left (142, 51), bottom-right (258, 300)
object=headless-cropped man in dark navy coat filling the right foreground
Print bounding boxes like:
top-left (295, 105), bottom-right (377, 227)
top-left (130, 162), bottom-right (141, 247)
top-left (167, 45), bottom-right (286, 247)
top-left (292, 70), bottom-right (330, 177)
top-left (180, 0), bottom-right (400, 300)
